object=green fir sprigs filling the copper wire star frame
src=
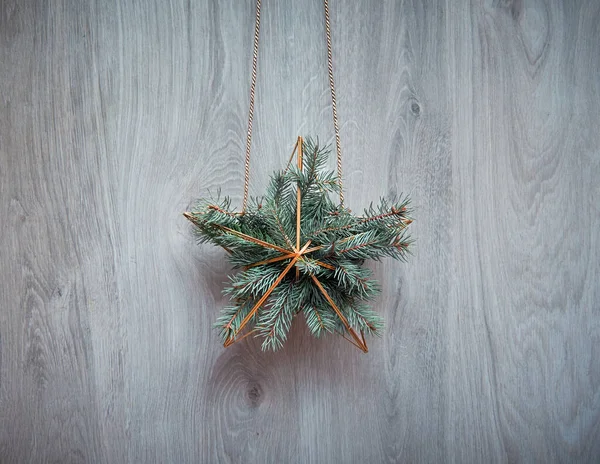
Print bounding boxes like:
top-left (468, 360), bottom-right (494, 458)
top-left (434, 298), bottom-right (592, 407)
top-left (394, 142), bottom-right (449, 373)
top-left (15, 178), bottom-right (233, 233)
top-left (186, 139), bottom-right (412, 350)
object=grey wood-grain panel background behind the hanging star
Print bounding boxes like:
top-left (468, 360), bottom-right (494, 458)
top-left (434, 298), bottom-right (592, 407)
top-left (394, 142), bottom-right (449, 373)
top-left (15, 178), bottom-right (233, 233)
top-left (0, 0), bottom-right (600, 463)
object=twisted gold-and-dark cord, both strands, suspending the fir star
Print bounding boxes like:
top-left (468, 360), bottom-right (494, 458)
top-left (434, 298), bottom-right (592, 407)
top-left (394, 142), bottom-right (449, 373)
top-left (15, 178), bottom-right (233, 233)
top-left (242, 0), bottom-right (344, 214)
